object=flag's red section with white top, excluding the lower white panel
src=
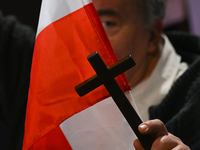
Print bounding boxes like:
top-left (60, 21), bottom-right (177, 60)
top-left (23, 0), bottom-right (130, 150)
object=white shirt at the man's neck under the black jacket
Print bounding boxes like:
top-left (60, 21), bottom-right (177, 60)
top-left (131, 35), bottom-right (188, 121)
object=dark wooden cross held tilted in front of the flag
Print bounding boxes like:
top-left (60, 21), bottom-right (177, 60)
top-left (75, 52), bottom-right (154, 150)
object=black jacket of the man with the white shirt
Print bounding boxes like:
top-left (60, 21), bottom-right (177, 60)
top-left (149, 33), bottom-right (200, 150)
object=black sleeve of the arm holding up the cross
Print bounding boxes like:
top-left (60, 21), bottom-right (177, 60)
top-left (149, 60), bottom-right (200, 150)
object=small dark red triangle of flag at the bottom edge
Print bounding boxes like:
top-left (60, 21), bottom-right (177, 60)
top-left (30, 126), bottom-right (72, 150)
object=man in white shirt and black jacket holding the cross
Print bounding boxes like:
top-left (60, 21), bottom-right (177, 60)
top-left (93, 0), bottom-right (200, 149)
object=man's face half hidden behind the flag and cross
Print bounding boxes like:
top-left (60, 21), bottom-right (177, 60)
top-left (93, 0), bottom-right (158, 86)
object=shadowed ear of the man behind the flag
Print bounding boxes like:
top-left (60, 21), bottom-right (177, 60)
top-left (148, 19), bottom-right (163, 53)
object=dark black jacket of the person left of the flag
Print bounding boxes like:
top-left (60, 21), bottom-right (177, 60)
top-left (0, 14), bottom-right (35, 150)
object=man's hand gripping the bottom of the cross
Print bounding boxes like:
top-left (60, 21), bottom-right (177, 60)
top-left (134, 119), bottom-right (190, 150)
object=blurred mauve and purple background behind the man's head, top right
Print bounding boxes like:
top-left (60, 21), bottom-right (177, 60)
top-left (164, 0), bottom-right (200, 35)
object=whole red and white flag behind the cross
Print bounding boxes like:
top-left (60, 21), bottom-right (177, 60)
top-left (23, 0), bottom-right (138, 150)
